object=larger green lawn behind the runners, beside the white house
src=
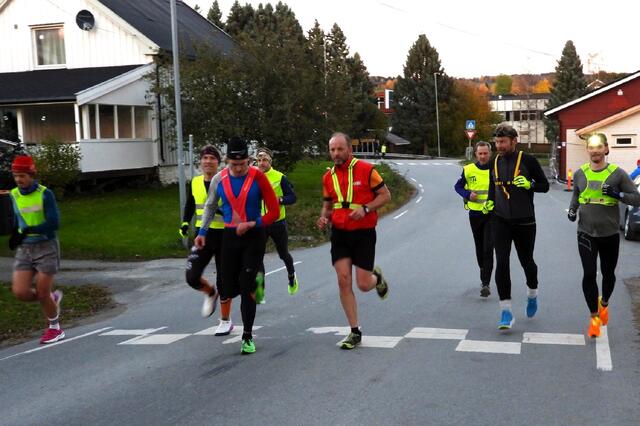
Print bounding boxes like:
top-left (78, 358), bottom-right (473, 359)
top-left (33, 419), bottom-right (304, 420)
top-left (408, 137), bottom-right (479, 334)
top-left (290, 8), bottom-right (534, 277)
top-left (0, 161), bottom-right (413, 260)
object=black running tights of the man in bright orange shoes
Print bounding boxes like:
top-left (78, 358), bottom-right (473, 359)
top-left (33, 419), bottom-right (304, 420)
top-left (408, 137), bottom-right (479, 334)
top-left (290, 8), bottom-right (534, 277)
top-left (578, 232), bottom-right (620, 314)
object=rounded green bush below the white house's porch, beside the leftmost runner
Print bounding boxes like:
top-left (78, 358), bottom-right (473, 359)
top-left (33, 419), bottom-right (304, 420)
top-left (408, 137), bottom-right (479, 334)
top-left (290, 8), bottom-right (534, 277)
top-left (33, 137), bottom-right (81, 197)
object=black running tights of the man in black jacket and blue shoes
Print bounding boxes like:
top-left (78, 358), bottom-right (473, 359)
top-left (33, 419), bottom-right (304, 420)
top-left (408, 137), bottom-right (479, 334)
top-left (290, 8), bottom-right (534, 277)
top-left (492, 215), bottom-right (538, 300)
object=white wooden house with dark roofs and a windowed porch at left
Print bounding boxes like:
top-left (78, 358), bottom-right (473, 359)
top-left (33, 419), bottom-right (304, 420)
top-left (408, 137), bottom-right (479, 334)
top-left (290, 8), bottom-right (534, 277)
top-left (0, 0), bottom-right (237, 181)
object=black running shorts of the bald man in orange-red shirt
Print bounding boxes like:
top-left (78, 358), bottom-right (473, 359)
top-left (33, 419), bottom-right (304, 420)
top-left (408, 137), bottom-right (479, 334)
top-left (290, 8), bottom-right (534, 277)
top-left (331, 228), bottom-right (376, 271)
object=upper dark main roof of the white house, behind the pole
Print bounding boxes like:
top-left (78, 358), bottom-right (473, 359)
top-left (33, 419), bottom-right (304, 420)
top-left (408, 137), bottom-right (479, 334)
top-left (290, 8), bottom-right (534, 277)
top-left (98, 0), bottom-right (238, 56)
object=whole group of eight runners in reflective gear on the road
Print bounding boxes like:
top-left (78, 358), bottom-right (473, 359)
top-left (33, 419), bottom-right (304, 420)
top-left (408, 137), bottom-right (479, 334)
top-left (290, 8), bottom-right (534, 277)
top-left (9, 125), bottom-right (640, 354)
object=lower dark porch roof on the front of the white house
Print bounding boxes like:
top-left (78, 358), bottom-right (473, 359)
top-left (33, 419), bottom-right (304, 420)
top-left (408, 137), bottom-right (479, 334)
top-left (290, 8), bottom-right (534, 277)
top-left (0, 65), bottom-right (144, 105)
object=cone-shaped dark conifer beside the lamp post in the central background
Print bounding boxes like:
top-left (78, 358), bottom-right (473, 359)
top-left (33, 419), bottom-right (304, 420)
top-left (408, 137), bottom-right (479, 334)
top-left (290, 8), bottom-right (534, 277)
top-left (391, 34), bottom-right (452, 154)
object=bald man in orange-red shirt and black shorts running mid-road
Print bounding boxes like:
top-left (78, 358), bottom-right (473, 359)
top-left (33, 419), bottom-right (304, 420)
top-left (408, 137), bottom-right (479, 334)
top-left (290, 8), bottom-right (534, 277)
top-left (317, 133), bottom-right (391, 349)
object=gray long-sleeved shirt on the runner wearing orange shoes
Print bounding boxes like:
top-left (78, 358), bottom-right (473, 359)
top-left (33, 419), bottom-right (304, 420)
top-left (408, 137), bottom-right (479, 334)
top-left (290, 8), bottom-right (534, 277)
top-left (569, 162), bottom-right (640, 237)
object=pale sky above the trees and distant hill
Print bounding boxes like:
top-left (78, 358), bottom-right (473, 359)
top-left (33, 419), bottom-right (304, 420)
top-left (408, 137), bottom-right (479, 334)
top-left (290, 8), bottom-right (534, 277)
top-left (185, 0), bottom-right (640, 78)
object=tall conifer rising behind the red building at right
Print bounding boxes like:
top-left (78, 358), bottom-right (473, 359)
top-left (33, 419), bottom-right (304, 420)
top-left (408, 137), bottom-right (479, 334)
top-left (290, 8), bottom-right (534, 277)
top-left (545, 40), bottom-right (587, 142)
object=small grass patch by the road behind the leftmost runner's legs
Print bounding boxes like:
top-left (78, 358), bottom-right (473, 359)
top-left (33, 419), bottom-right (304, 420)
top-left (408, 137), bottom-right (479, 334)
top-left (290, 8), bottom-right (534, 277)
top-left (0, 282), bottom-right (112, 345)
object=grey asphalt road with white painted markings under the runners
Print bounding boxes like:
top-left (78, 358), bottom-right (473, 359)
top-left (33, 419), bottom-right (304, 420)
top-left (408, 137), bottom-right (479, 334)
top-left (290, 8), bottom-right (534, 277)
top-left (0, 160), bottom-right (640, 425)
